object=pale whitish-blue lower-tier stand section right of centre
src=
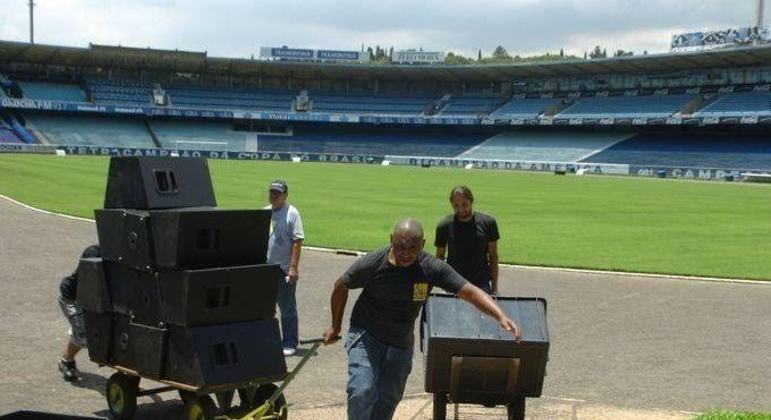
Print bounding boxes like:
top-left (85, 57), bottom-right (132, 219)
top-left (458, 130), bottom-right (633, 162)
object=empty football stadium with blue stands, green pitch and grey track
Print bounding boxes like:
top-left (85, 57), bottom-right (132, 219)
top-left (0, 2), bottom-right (771, 420)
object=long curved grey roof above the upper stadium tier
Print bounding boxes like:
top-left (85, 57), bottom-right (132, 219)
top-left (0, 41), bottom-right (771, 82)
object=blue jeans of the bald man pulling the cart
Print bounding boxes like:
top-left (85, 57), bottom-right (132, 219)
top-left (345, 327), bottom-right (413, 420)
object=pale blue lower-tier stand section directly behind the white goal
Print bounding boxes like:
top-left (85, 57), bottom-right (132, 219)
top-left (150, 120), bottom-right (256, 151)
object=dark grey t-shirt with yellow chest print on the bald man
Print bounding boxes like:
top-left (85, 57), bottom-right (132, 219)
top-left (342, 247), bottom-right (467, 348)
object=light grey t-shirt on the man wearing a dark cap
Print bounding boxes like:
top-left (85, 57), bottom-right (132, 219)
top-left (265, 203), bottom-right (305, 271)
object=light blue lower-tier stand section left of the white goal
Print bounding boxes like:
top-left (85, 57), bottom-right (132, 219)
top-left (27, 114), bottom-right (155, 148)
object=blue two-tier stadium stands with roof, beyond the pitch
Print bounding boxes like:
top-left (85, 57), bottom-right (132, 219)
top-left (0, 42), bottom-right (771, 179)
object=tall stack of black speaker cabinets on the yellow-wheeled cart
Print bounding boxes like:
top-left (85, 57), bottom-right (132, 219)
top-left (78, 157), bottom-right (286, 387)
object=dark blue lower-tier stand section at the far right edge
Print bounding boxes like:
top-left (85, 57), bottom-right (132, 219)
top-left (584, 132), bottom-right (771, 170)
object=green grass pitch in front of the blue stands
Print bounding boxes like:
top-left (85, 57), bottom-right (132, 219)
top-left (0, 154), bottom-right (771, 280)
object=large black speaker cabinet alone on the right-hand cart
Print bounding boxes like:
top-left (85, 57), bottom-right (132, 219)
top-left (423, 295), bottom-right (549, 405)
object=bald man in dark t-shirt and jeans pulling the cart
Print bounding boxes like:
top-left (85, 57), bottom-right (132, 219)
top-left (324, 219), bottom-right (520, 420)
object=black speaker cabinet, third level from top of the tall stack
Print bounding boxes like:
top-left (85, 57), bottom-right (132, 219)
top-left (103, 261), bottom-right (283, 326)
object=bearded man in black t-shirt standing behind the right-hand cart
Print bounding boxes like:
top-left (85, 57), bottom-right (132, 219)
top-left (434, 185), bottom-right (500, 295)
